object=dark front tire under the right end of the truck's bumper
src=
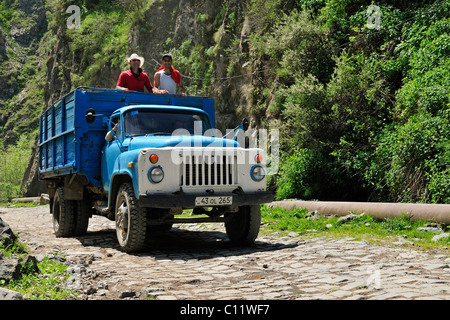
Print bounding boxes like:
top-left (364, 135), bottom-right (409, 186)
top-left (225, 205), bottom-right (261, 245)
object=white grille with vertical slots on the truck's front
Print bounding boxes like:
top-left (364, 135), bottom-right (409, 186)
top-left (181, 152), bottom-right (238, 187)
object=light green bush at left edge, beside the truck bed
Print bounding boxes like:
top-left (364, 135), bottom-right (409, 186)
top-left (0, 135), bottom-right (33, 202)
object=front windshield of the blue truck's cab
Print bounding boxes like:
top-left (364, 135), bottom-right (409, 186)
top-left (123, 109), bottom-right (211, 137)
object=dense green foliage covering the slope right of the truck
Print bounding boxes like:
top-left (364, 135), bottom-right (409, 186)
top-left (250, 0), bottom-right (450, 203)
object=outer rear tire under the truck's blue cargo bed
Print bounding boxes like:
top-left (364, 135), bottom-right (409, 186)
top-left (52, 187), bottom-right (75, 238)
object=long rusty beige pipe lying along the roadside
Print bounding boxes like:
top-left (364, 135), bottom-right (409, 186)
top-left (267, 200), bottom-right (450, 225)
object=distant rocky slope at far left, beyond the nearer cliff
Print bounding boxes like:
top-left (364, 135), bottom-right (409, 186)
top-left (0, 0), bottom-right (48, 145)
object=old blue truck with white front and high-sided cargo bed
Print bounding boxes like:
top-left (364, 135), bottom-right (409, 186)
top-left (39, 87), bottom-right (273, 252)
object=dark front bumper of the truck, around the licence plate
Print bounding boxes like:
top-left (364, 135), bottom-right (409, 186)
top-left (139, 191), bottom-right (274, 209)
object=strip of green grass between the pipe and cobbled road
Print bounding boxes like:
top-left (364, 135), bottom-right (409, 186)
top-left (261, 205), bottom-right (450, 249)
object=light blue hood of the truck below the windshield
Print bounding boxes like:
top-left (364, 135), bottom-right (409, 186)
top-left (124, 135), bottom-right (240, 151)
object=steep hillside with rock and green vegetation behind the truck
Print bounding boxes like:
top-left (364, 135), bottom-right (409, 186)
top-left (0, 0), bottom-right (450, 203)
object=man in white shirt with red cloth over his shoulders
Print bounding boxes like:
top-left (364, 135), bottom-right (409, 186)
top-left (153, 53), bottom-right (186, 97)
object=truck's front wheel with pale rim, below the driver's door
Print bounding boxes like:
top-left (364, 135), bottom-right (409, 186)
top-left (115, 183), bottom-right (147, 252)
